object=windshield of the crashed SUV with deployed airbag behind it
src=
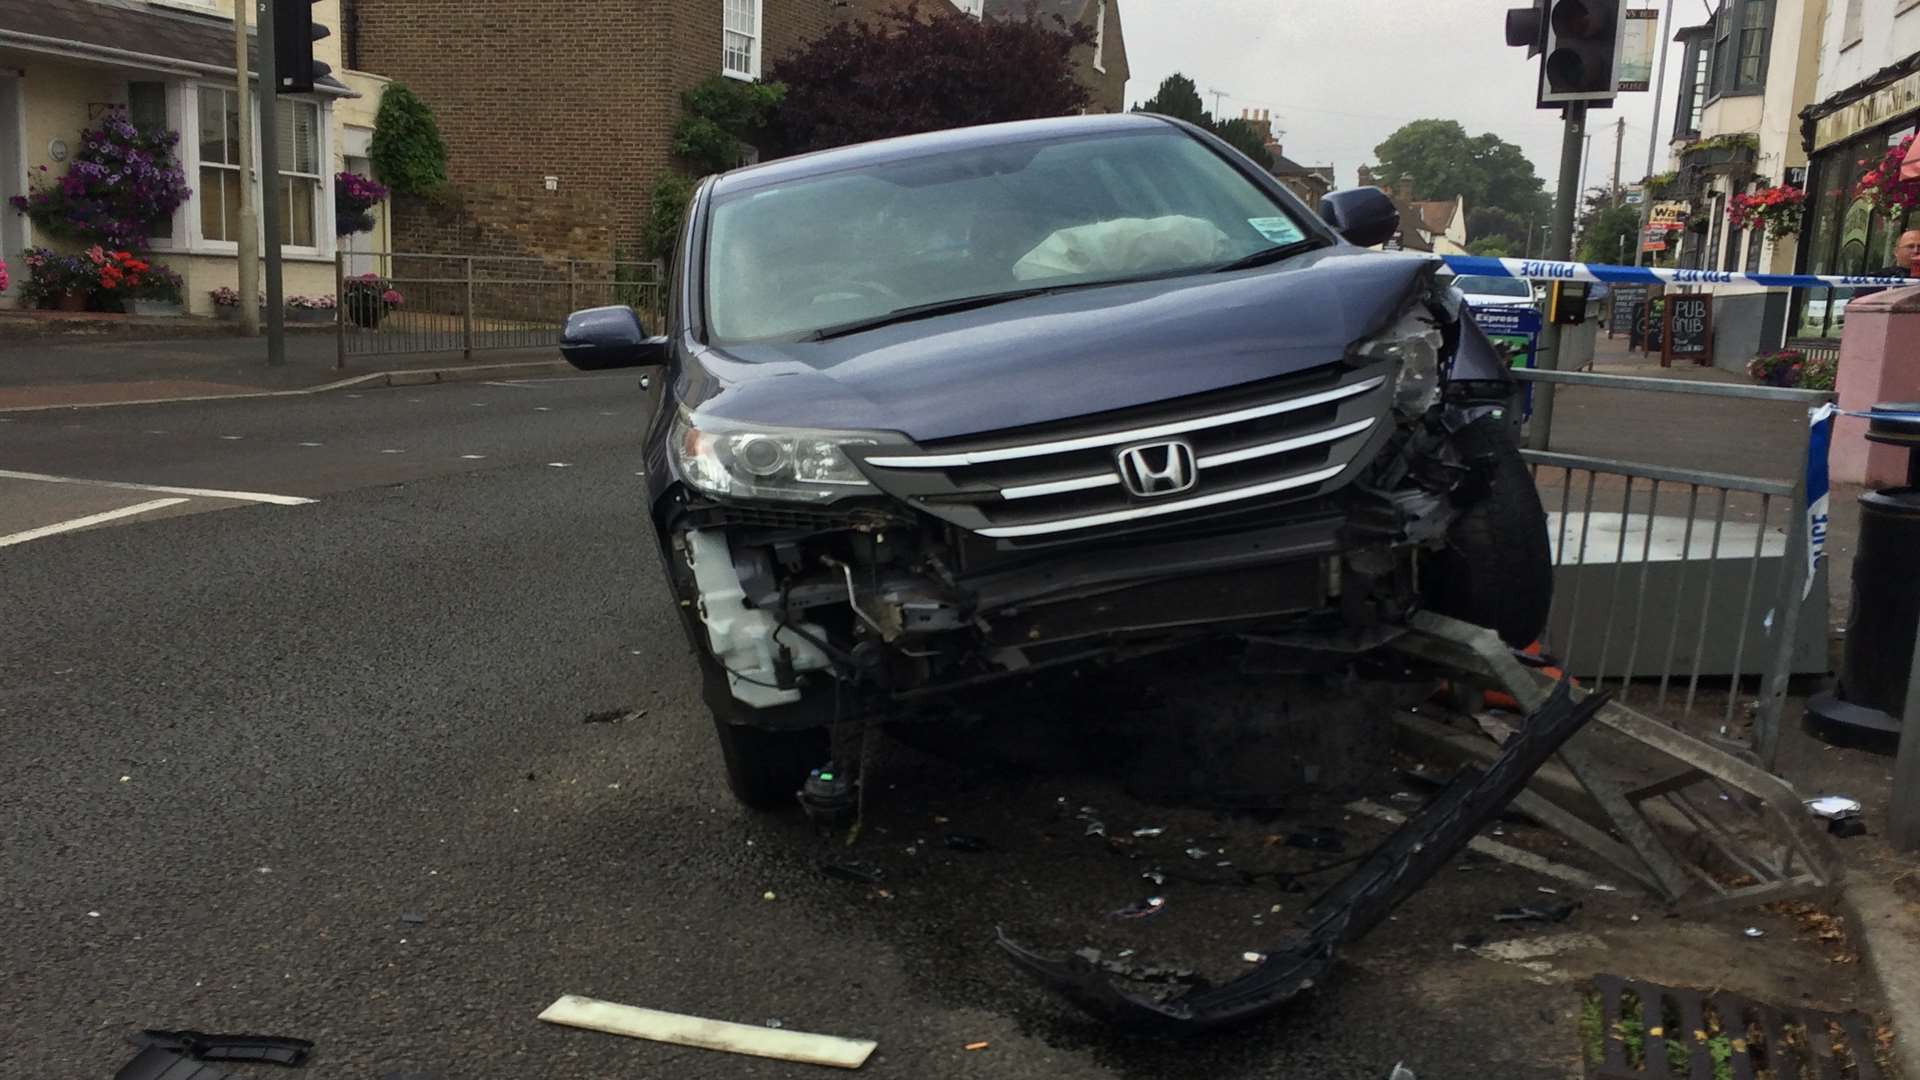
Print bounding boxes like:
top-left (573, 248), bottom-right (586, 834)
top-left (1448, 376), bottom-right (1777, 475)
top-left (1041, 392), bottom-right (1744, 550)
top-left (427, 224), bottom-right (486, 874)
top-left (707, 127), bottom-right (1311, 342)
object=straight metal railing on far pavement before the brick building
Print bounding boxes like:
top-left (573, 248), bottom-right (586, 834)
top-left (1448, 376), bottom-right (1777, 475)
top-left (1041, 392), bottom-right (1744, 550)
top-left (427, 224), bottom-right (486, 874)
top-left (334, 252), bottom-right (660, 367)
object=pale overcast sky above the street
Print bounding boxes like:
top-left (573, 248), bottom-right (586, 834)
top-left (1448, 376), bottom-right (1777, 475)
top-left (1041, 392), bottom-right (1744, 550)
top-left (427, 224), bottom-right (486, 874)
top-left (1119, 0), bottom-right (1705, 192)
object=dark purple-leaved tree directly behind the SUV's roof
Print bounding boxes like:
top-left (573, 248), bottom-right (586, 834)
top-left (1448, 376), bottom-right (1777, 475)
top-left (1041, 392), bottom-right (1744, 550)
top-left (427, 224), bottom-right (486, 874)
top-left (766, 4), bottom-right (1092, 154)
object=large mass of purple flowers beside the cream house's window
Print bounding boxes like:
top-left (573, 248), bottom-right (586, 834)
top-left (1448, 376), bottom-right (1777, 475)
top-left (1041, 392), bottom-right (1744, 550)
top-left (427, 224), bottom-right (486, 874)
top-left (8, 110), bottom-right (192, 252)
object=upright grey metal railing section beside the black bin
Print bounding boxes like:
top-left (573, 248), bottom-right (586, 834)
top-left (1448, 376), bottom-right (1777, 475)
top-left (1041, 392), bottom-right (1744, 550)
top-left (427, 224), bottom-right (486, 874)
top-left (1515, 369), bottom-right (1834, 767)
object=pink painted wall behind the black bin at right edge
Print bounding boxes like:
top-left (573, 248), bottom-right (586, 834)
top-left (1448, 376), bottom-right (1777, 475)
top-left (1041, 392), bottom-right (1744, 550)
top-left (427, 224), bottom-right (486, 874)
top-left (1828, 286), bottom-right (1920, 488)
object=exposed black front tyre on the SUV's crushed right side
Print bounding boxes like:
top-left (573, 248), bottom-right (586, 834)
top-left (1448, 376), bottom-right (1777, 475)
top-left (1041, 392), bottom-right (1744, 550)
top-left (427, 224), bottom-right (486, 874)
top-left (1425, 419), bottom-right (1553, 650)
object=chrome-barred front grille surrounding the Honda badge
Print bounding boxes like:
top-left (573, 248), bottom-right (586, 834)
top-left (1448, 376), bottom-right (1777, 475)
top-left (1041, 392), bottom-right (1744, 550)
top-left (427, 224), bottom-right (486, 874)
top-left (860, 363), bottom-right (1392, 540)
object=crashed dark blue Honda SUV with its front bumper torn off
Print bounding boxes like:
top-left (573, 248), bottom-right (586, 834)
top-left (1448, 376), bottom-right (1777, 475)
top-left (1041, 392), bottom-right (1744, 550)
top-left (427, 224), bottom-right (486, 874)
top-left (561, 113), bottom-right (1551, 807)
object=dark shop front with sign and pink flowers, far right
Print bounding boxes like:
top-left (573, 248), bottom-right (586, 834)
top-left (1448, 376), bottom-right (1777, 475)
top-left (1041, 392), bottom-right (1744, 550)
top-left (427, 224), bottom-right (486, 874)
top-left (1791, 54), bottom-right (1920, 348)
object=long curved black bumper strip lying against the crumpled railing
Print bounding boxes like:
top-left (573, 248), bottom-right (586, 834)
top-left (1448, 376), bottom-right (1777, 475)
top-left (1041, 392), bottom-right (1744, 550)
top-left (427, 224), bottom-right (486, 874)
top-left (998, 678), bottom-right (1611, 1036)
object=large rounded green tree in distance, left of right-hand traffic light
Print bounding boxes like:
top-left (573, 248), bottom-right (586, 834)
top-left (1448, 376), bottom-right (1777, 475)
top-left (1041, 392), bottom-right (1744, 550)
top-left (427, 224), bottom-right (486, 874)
top-left (1373, 119), bottom-right (1549, 223)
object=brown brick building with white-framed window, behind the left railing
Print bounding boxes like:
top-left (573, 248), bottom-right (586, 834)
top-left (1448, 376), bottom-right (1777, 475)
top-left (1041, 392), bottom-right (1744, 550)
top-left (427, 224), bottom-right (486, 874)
top-left (342, 0), bottom-right (913, 258)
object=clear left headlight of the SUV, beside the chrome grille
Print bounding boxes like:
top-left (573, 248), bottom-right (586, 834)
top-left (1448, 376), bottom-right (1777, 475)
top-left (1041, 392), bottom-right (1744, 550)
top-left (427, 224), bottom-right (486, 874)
top-left (672, 409), bottom-right (881, 502)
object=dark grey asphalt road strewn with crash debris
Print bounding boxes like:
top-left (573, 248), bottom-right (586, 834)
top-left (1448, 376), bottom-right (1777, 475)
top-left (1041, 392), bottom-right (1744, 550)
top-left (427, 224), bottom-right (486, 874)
top-left (0, 377), bottom-right (1858, 1080)
